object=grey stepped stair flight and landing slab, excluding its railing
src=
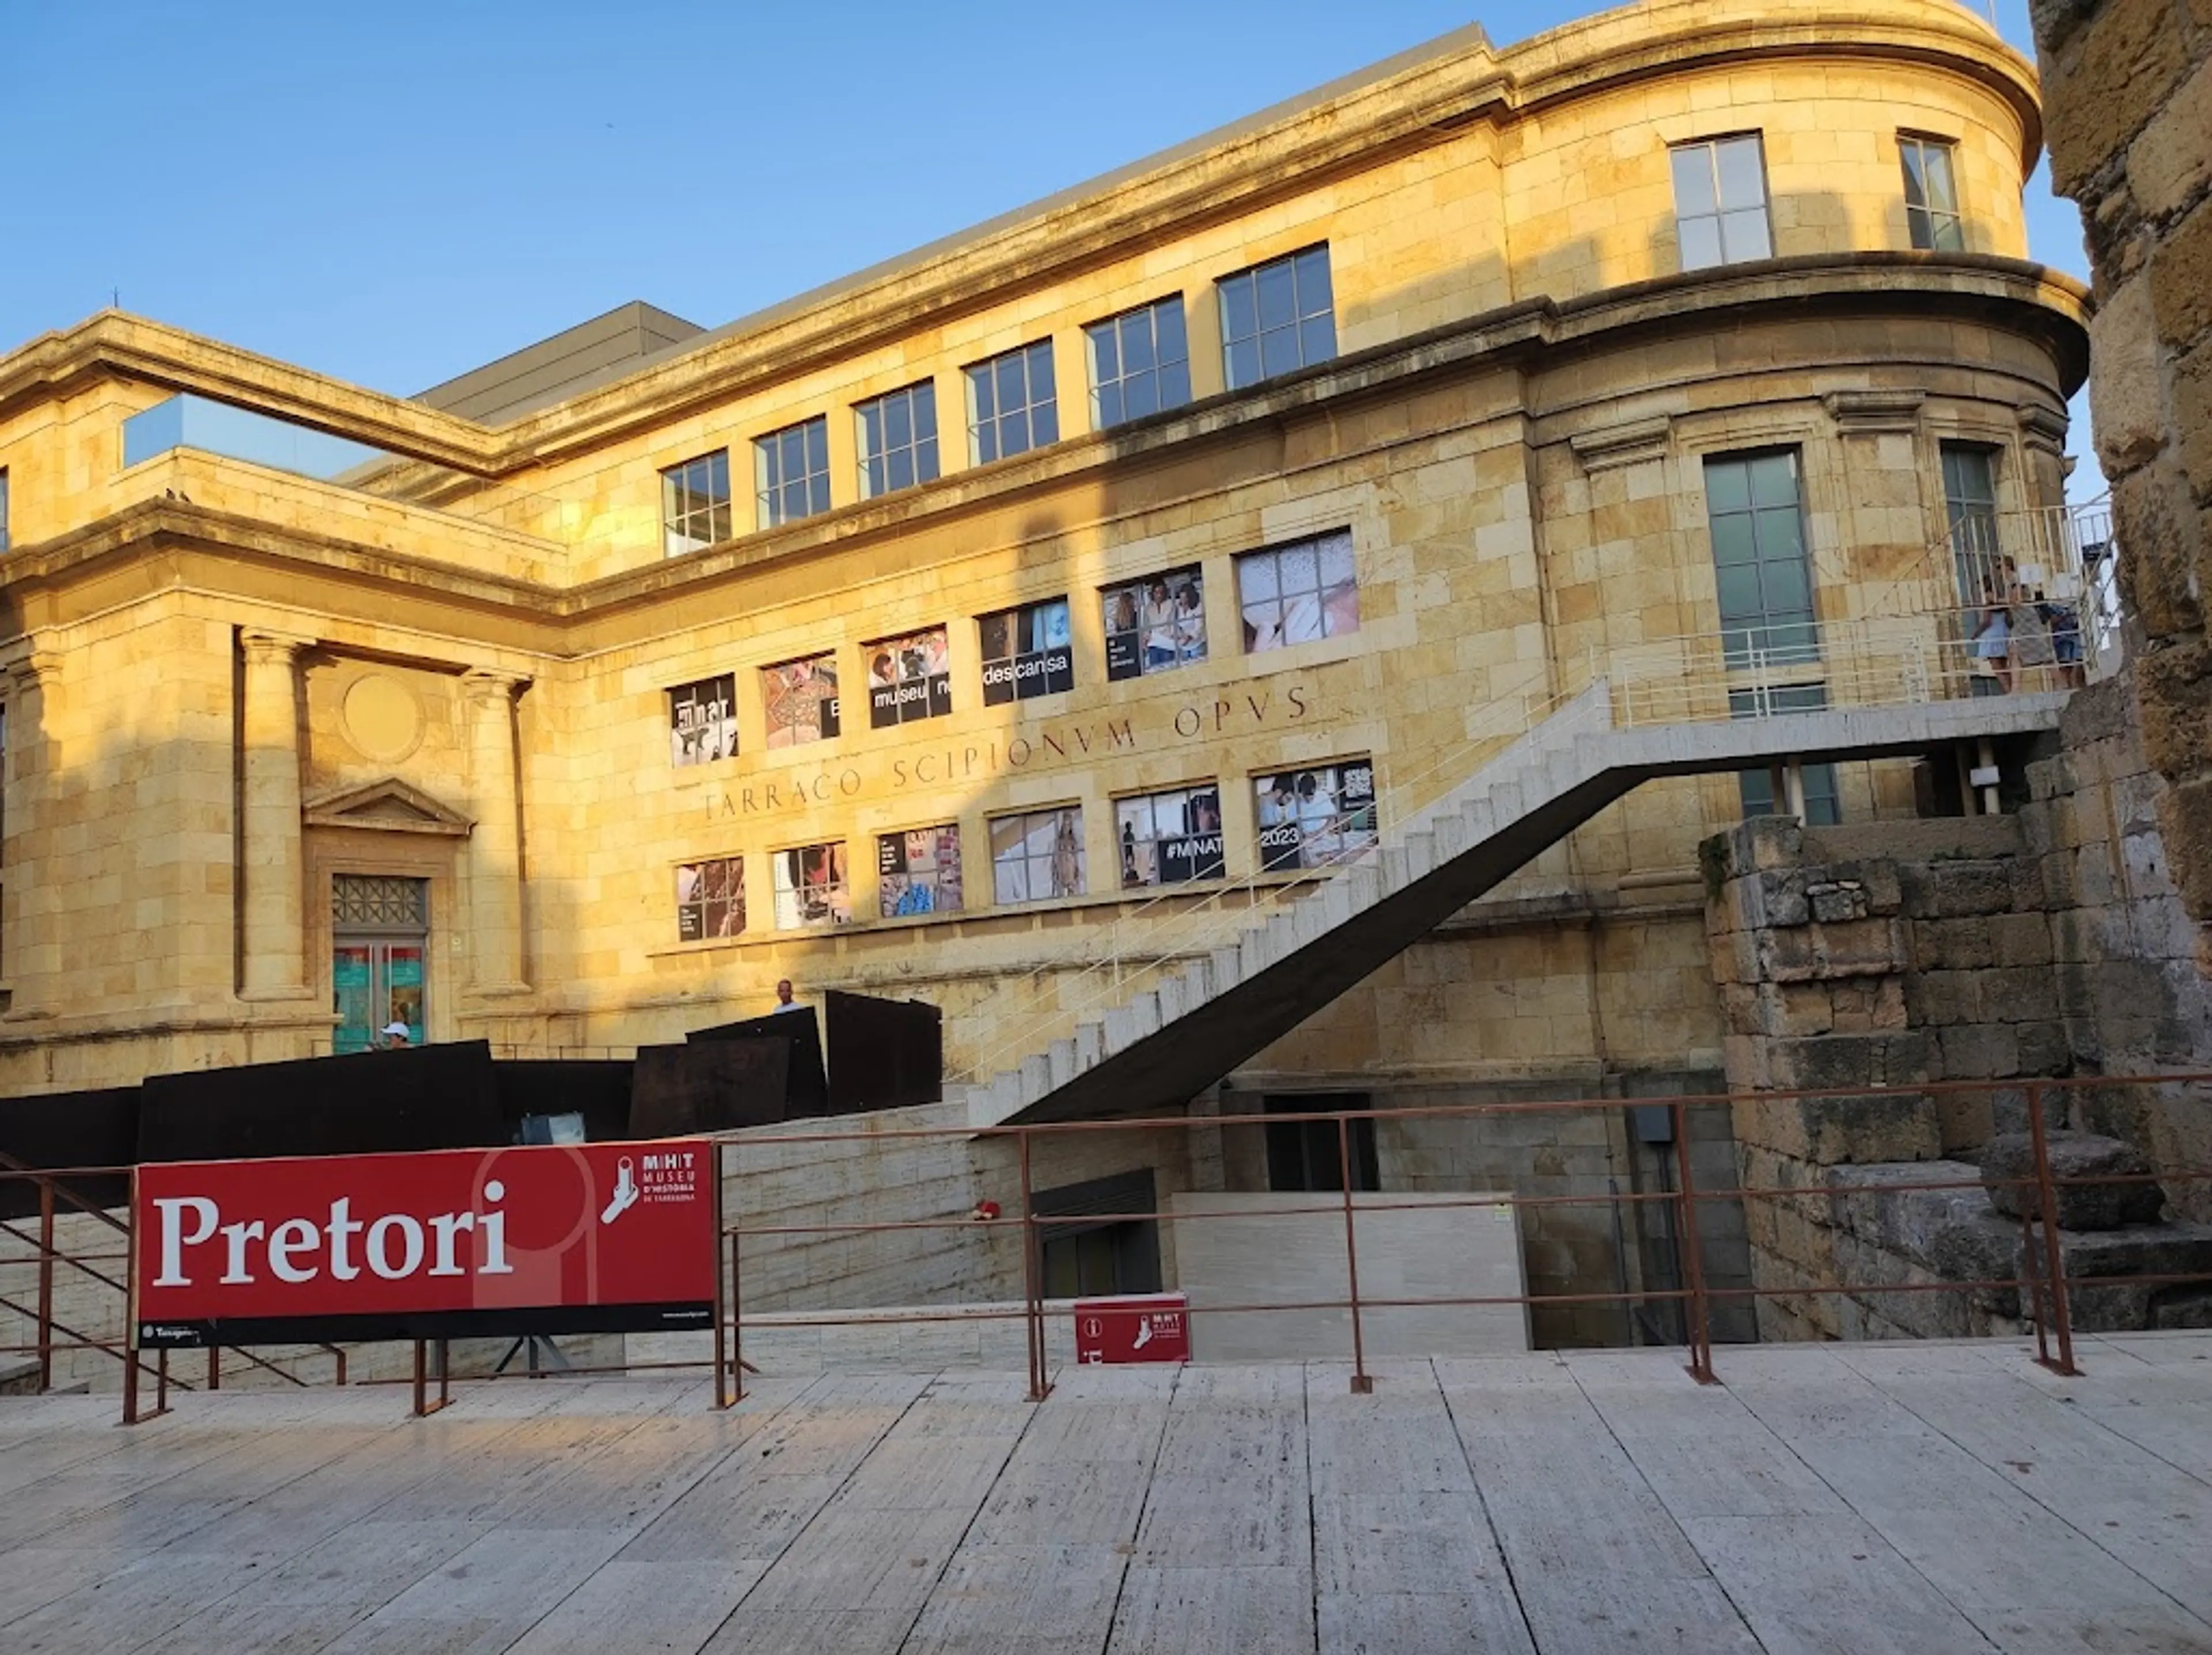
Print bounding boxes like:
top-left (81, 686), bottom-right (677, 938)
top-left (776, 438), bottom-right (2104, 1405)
top-left (947, 679), bottom-right (2066, 1126)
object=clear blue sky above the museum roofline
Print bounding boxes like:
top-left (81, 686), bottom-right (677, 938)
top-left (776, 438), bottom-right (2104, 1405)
top-left (0, 0), bottom-right (2093, 491)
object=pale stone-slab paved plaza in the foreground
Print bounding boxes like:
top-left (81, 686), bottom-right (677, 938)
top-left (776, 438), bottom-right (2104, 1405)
top-left (0, 1334), bottom-right (2212, 1655)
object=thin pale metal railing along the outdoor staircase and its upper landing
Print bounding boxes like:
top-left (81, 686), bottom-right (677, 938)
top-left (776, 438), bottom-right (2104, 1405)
top-left (949, 608), bottom-right (2073, 1097)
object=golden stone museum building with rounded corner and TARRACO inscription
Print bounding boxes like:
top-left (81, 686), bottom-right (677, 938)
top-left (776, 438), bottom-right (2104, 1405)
top-left (0, 0), bottom-right (2086, 1327)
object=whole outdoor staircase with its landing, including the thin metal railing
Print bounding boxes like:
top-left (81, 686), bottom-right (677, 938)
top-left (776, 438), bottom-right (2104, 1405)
top-left (951, 615), bottom-right (2066, 1126)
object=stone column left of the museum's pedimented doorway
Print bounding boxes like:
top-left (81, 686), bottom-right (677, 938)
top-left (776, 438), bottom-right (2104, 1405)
top-left (239, 633), bottom-right (314, 1000)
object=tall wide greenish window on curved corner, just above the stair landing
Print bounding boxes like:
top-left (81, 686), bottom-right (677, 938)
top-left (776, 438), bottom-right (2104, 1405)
top-left (1706, 449), bottom-right (1820, 668)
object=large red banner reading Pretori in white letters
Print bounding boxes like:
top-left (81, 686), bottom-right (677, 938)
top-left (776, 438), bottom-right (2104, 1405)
top-left (131, 1137), bottom-right (719, 1347)
